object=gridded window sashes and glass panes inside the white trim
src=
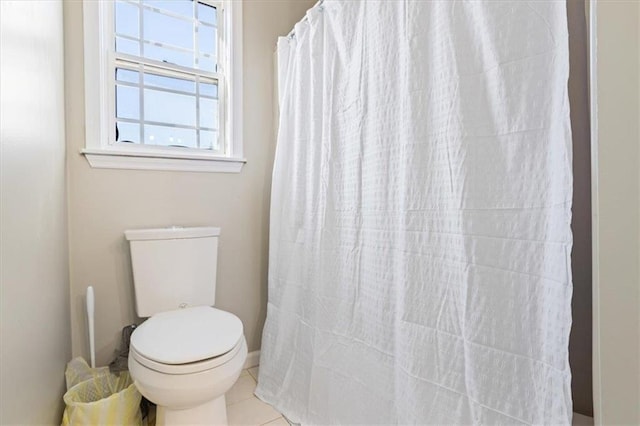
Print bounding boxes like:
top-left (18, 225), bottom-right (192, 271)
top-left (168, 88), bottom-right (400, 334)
top-left (113, 0), bottom-right (228, 155)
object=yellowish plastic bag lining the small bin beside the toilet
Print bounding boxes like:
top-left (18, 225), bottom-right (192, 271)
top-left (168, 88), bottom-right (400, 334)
top-left (62, 357), bottom-right (142, 426)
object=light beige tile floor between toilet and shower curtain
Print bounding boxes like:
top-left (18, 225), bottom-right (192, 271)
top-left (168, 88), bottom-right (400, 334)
top-left (226, 367), bottom-right (289, 426)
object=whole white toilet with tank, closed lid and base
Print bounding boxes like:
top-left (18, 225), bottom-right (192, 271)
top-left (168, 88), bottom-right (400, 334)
top-left (125, 227), bottom-right (247, 425)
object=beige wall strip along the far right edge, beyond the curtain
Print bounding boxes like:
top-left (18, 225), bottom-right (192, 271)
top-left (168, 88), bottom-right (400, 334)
top-left (592, 1), bottom-right (640, 425)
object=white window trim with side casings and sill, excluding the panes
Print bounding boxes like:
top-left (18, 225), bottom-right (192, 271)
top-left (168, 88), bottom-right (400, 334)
top-left (81, 0), bottom-right (246, 173)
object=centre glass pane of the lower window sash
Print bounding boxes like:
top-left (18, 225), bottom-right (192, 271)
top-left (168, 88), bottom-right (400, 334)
top-left (144, 89), bottom-right (196, 127)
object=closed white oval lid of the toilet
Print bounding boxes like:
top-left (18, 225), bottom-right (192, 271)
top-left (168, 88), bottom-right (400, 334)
top-left (131, 306), bottom-right (243, 365)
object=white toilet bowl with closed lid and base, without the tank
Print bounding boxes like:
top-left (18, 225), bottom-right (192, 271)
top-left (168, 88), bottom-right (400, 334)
top-left (129, 306), bottom-right (247, 425)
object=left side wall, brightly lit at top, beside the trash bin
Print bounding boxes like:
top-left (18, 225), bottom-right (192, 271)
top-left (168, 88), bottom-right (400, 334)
top-left (0, 0), bottom-right (71, 425)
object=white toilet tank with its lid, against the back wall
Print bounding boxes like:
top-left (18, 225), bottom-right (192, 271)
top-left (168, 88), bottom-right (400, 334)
top-left (125, 227), bottom-right (220, 317)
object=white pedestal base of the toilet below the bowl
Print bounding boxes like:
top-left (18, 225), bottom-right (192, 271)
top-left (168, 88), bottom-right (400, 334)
top-left (156, 394), bottom-right (227, 426)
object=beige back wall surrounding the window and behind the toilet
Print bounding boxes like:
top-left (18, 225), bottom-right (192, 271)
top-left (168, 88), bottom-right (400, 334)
top-left (64, 0), bottom-right (314, 365)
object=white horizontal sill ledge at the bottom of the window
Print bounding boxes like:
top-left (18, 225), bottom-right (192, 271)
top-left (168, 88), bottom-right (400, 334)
top-left (81, 149), bottom-right (247, 173)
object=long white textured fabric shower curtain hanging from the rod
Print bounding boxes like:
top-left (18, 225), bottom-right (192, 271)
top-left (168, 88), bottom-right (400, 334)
top-left (256, 0), bottom-right (572, 425)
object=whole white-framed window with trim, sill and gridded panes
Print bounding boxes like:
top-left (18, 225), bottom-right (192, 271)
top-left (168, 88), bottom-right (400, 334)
top-left (83, 0), bottom-right (244, 172)
